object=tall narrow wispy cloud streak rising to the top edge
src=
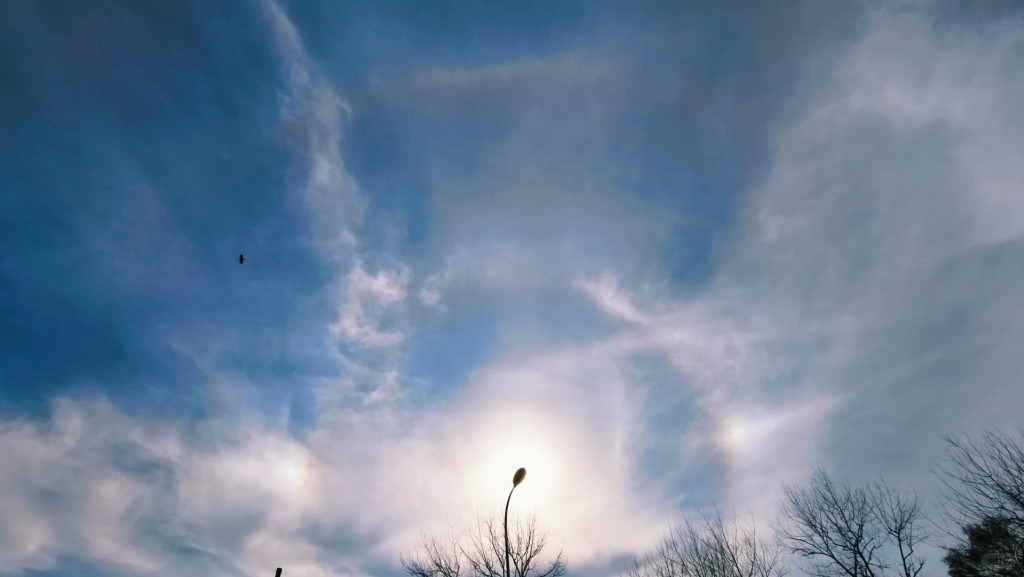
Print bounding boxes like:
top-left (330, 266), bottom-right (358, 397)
top-left (261, 0), bottom-right (411, 416)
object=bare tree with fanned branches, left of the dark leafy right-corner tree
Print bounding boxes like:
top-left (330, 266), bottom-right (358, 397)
top-left (776, 469), bottom-right (927, 577)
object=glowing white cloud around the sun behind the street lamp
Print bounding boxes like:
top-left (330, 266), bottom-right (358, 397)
top-left (303, 349), bottom-right (679, 560)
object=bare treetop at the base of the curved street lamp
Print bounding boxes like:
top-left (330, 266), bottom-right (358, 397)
top-left (401, 516), bottom-right (566, 577)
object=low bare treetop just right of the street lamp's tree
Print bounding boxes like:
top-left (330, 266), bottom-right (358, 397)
top-left (626, 509), bottom-right (786, 577)
